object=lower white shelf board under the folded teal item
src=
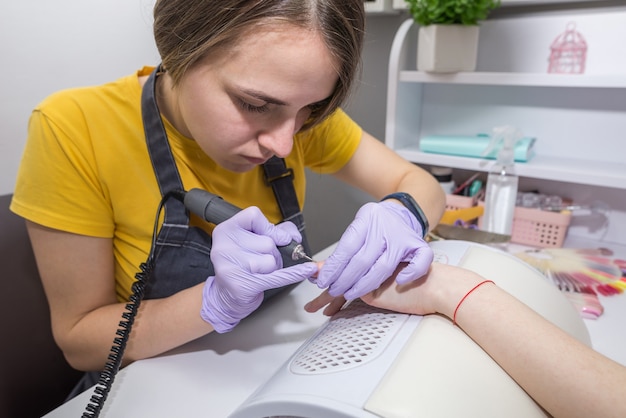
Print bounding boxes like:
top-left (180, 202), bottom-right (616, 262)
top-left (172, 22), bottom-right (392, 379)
top-left (396, 147), bottom-right (626, 189)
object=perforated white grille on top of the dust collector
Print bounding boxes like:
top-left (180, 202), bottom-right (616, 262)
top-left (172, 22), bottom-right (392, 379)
top-left (290, 300), bottom-right (409, 374)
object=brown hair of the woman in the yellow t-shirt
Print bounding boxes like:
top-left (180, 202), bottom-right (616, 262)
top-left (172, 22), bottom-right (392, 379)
top-left (154, 0), bottom-right (365, 129)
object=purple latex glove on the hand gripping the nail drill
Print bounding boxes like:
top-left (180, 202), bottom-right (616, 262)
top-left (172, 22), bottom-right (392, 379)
top-left (200, 207), bottom-right (318, 333)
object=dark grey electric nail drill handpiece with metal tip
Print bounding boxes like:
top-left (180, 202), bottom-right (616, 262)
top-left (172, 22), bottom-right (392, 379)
top-left (174, 189), bottom-right (313, 261)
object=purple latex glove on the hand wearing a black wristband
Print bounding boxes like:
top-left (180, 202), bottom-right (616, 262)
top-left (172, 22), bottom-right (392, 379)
top-left (315, 200), bottom-right (434, 299)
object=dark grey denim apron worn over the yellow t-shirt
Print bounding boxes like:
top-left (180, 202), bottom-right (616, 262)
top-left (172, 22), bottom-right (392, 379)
top-left (67, 66), bottom-right (311, 400)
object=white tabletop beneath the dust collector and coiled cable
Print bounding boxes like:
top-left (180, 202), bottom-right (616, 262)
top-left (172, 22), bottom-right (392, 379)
top-left (46, 243), bottom-right (626, 418)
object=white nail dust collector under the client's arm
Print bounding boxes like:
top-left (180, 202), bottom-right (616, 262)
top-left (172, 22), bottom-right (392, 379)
top-left (231, 241), bottom-right (590, 418)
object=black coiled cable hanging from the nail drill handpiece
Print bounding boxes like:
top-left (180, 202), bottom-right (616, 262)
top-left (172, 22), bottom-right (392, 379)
top-left (81, 190), bottom-right (180, 418)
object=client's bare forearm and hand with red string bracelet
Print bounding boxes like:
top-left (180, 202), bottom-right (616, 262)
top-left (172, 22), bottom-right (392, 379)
top-left (306, 263), bottom-right (626, 418)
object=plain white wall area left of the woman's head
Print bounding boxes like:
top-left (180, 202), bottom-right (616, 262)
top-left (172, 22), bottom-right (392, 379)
top-left (0, 0), bottom-right (159, 194)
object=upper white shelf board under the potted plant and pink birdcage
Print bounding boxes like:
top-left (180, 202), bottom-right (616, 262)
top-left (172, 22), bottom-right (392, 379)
top-left (399, 71), bottom-right (626, 88)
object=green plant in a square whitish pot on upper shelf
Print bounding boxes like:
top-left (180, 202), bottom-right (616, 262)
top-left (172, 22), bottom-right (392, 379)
top-left (405, 0), bottom-right (500, 73)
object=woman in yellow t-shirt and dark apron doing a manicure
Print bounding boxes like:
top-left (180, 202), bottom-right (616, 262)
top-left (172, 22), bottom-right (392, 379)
top-left (11, 0), bottom-right (444, 370)
